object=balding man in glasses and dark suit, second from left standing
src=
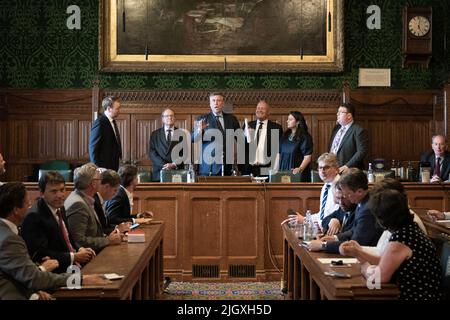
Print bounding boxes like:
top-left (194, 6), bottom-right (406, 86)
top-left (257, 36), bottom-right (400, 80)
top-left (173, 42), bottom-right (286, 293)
top-left (148, 109), bottom-right (185, 182)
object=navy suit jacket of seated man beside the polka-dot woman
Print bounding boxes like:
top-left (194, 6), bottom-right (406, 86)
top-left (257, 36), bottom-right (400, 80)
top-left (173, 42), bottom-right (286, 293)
top-left (326, 195), bottom-right (383, 253)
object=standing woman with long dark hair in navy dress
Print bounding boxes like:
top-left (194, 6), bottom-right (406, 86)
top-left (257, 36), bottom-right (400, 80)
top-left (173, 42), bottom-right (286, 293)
top-left (278, 111), bottom-right (313, 182)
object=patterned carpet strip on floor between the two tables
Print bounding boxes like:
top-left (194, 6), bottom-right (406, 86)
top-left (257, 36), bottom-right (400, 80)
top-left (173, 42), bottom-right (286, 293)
top-left (161, 281), bottom-right (285, 300)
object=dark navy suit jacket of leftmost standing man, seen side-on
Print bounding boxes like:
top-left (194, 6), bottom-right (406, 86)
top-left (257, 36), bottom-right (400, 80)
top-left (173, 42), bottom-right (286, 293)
top-left (89, 114), bottom-right (122, 171)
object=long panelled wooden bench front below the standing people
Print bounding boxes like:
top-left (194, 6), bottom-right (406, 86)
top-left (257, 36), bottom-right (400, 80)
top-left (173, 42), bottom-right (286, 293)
top-left (23, 181), bottom-right (450, 281)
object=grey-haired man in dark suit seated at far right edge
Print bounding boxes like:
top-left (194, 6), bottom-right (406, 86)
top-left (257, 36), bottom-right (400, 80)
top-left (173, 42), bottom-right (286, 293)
top-left (420, 134), bottom-right (450, 182)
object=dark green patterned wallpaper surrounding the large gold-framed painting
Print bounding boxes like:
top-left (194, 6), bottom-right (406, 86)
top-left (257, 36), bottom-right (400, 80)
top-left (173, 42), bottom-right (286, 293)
top-left (0, 0), bottom-right (450, 89)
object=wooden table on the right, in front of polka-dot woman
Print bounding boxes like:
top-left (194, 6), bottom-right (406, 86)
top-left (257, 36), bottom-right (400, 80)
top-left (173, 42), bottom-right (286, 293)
top-left (282, 224), bottom-right (399, 300)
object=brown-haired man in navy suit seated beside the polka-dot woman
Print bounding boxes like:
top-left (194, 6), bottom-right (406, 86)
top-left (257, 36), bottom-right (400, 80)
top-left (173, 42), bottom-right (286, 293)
top-left (309, 168), bottom-right (383, 253)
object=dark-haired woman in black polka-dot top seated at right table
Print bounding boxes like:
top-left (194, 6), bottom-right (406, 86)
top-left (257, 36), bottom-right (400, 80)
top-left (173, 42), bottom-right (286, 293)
top-left (342, 187), bottom-right (441, 300)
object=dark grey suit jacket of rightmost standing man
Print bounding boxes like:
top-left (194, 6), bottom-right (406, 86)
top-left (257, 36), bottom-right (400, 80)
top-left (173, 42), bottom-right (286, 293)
top-left (328, 122), bottom-right (369, 170)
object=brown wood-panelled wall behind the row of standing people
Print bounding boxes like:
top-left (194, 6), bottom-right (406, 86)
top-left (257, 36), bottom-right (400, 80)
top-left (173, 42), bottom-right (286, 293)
top-left (0, 87), bottom-right (448, 180)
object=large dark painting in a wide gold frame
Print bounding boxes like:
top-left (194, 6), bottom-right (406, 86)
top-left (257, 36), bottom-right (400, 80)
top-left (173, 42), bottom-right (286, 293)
top-left (99, 0), bottom-right (344, 72)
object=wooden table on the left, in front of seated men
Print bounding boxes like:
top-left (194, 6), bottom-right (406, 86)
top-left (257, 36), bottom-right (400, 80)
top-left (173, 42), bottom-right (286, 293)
top-left (53, 224), bottom-right (165, 300)
